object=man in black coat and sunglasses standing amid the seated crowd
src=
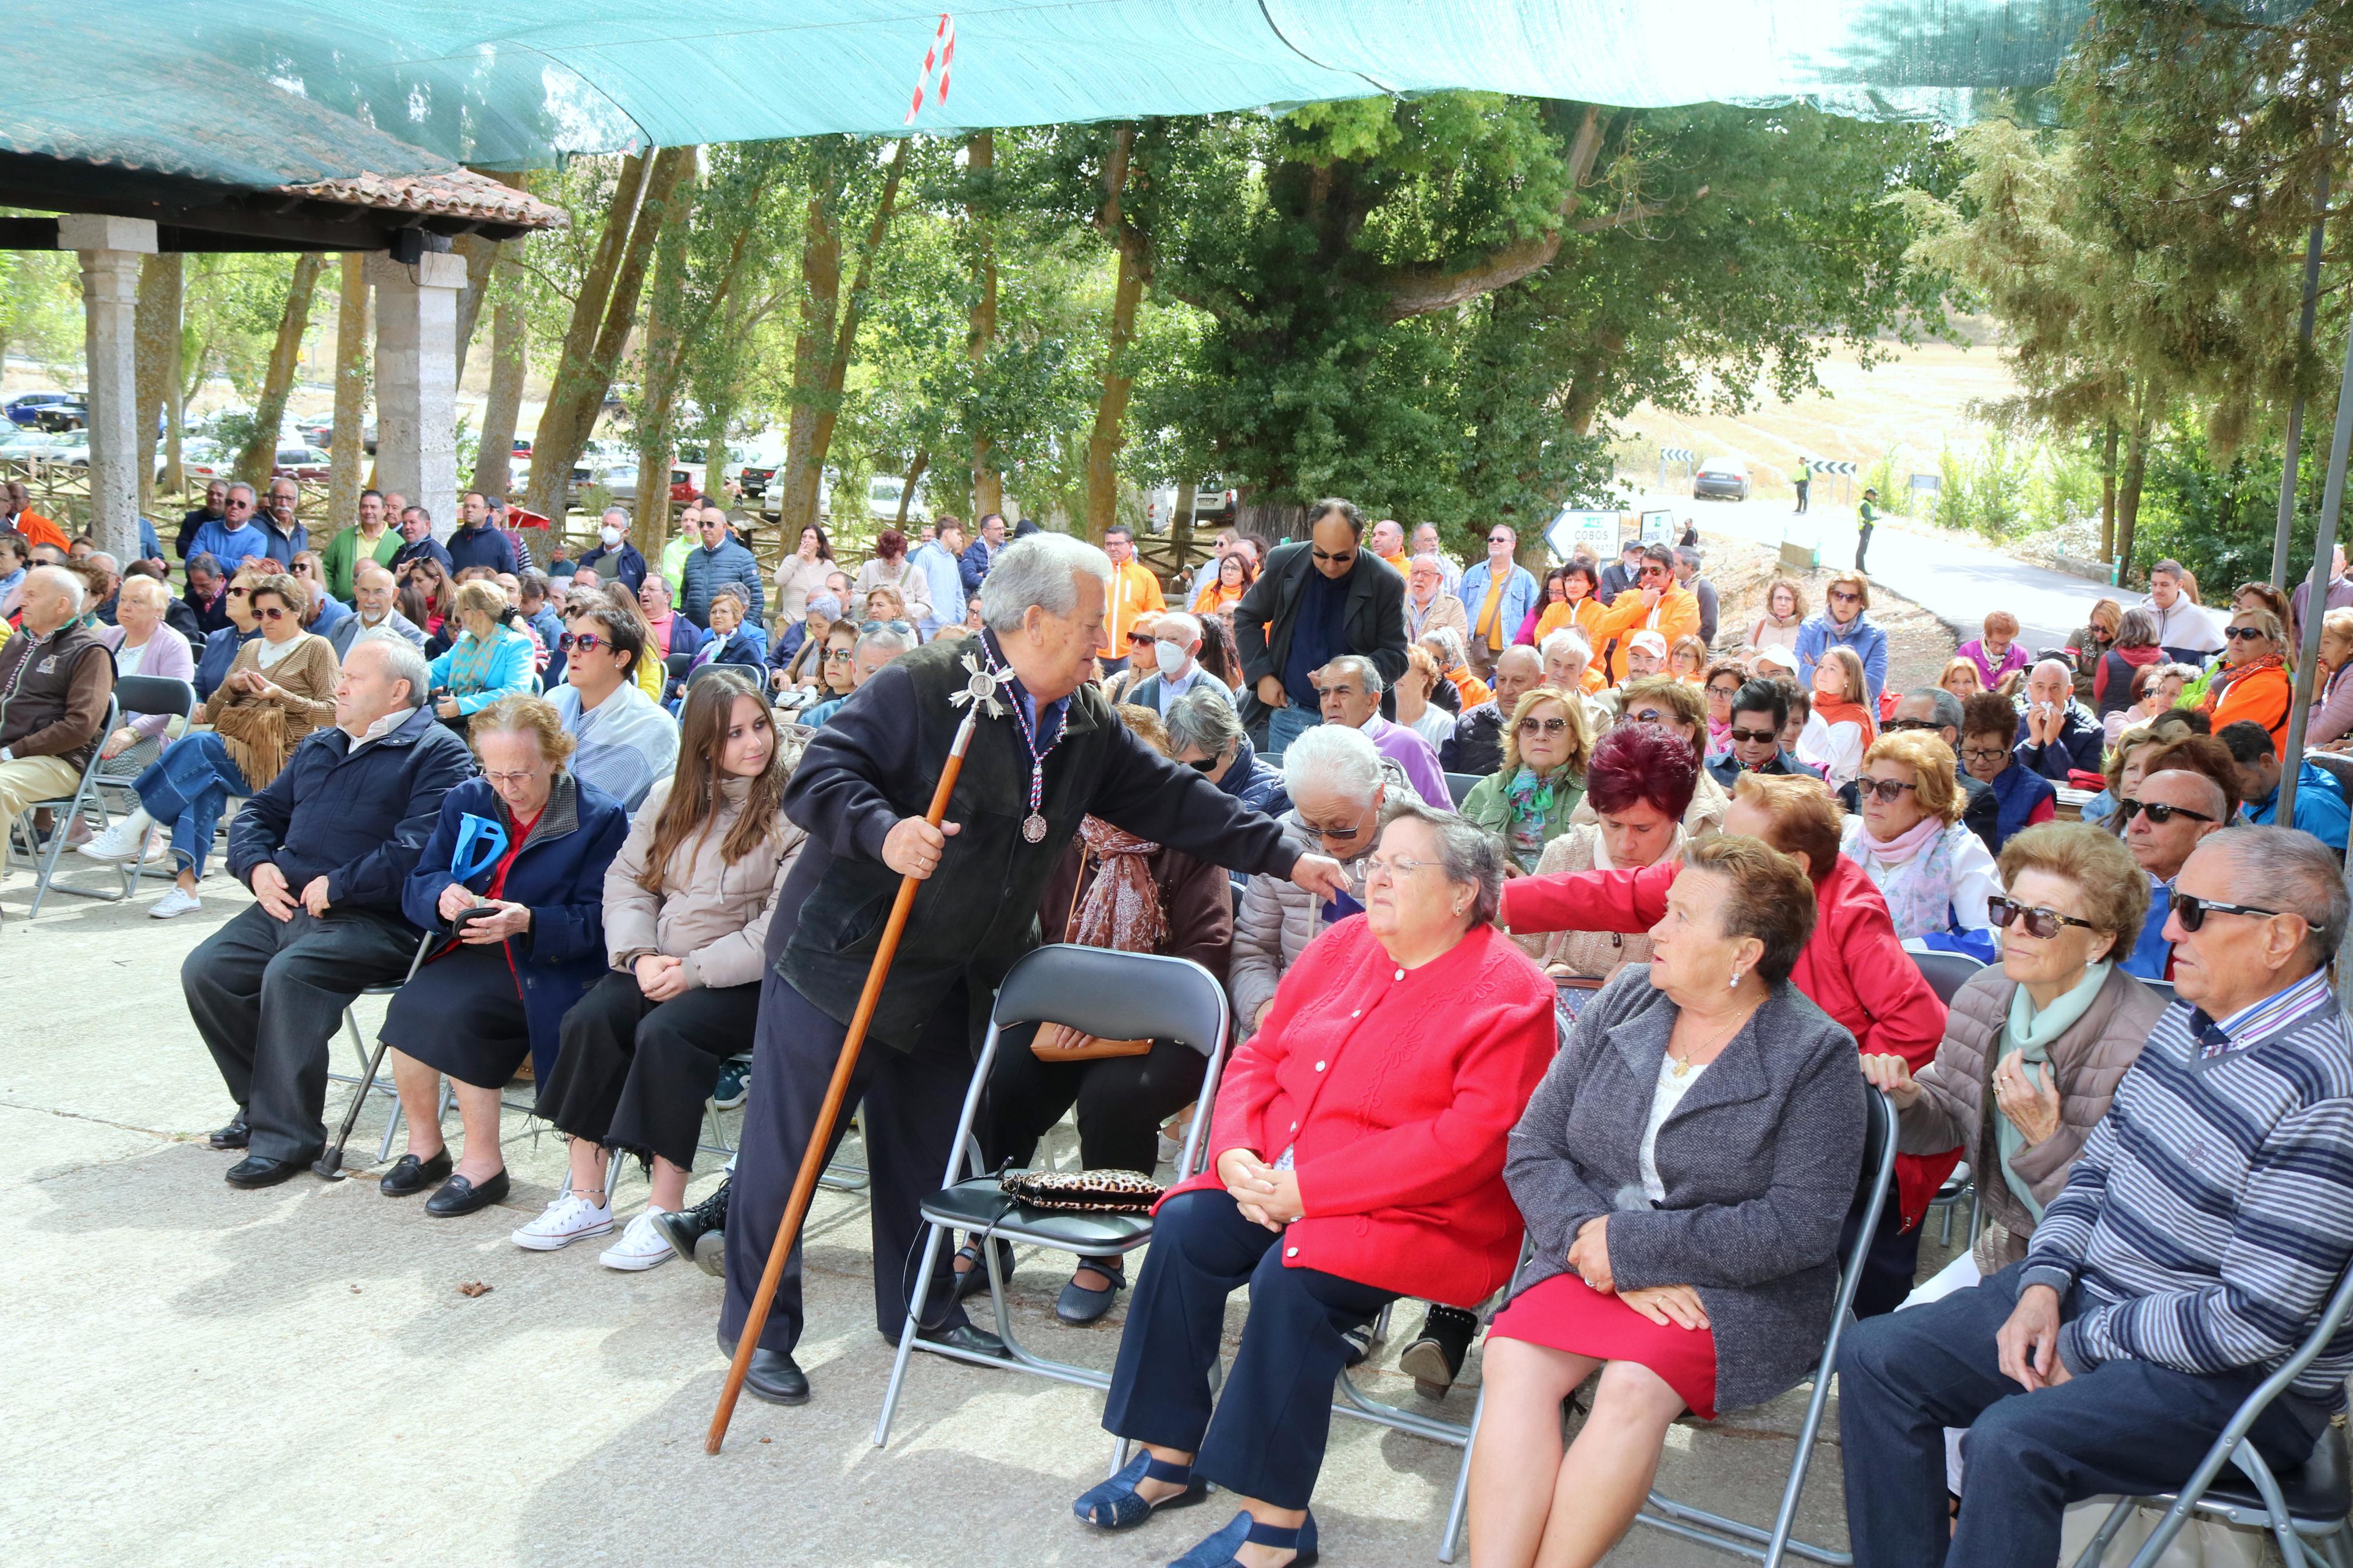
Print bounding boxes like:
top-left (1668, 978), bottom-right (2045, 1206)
top-left (1233, 499), bottom-right (1405, 762)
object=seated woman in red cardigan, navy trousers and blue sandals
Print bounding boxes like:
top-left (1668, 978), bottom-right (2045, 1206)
top-left (1076, 804), bottom-right (1555, 1568)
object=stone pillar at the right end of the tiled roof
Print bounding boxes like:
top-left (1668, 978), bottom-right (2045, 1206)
top-left (367, 251), bottom-right (466, 538)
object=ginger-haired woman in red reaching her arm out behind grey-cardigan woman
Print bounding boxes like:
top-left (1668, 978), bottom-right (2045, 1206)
top-left (1501, 773), bottom-right (1960, 1317)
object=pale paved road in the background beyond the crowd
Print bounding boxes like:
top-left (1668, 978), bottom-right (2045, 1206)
top-left (1635, 496), bottom-right (2136, 649)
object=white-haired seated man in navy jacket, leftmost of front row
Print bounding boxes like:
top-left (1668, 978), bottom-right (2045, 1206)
top-left (179, 637), bottom-right (473, 1187)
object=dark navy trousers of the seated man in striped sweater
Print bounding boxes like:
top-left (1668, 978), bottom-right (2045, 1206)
top-left (1838, 1263), bottom-right (2327, 1568)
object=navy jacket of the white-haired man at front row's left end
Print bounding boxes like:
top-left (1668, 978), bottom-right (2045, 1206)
top-left (228, 707), bottom-right (473, 915)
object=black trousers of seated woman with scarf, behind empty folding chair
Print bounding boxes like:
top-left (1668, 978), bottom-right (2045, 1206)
top-left (981, 1025), bottom-right (1209, 1175)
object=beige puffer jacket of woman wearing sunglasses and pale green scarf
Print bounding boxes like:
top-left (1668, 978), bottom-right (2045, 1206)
top-left (1899, 966), bottom-right (2165, 1274)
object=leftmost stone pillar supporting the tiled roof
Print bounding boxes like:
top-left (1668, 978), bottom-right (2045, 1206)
top-left (56, 212), bottom-right (155, 564)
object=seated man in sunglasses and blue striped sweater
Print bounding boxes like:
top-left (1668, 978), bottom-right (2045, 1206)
top-left (1838, 827), bottom-right (2353, 1568)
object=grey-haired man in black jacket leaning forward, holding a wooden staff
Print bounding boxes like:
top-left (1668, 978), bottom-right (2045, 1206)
top-left (720, 534), bottom-right (1346, 1403)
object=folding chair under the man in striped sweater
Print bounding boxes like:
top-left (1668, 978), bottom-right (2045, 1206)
top-left (2075, 1270), bottom-right (2353, 1568)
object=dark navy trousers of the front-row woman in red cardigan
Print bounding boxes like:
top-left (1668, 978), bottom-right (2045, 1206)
top-left (1103, 1189), bottom-right (1395, 1509)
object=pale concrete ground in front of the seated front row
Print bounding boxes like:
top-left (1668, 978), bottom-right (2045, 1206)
top-left (0, 872), bottom-right (1910, 1568)
